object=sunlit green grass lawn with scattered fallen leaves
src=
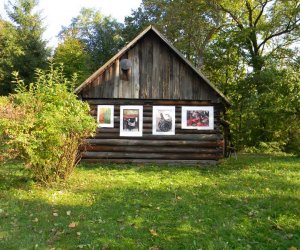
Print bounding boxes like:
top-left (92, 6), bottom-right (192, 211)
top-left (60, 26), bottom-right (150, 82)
top-left (0, 155), bottom-right (300, 250)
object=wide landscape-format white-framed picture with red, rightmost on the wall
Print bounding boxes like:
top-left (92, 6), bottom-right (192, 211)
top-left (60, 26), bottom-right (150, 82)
top-left (181, 106), bottom-right (214, 130)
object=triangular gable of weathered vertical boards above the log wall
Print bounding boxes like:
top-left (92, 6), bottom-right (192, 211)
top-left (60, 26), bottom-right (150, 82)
top-left (79, 31), bottom-right (221, 103)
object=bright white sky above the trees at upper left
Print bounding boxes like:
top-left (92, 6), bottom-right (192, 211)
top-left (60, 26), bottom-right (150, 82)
top-left (0, 0), bottom-right (142, 47)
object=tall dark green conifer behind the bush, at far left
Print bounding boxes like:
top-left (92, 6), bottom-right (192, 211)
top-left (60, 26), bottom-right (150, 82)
top-left (6, 0), bottom-right (50, 90)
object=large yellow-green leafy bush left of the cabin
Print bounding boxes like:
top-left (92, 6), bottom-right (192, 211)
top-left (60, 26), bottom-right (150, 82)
top-left (0, 66), bottom-right (96, 183)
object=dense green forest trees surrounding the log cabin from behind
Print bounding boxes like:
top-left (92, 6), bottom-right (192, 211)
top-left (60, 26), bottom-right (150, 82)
top-left (0, 0), bottom-right (300, 154)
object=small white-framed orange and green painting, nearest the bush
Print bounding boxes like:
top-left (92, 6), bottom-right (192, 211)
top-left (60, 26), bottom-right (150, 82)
top-left (97, 105), bottom-right (114, 128)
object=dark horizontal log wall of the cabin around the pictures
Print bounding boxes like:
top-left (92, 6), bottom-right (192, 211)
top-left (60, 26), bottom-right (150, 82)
top-left (83, 99), bottom-right (223, 164)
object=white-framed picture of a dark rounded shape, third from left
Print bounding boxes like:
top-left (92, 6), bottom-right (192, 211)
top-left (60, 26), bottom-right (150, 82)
top-left (152, 106), bottom-right (175, 135)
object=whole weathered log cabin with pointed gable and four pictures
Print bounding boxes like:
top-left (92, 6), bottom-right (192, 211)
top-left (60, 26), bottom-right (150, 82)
top-left (75, 26), bottom-right (230, 164)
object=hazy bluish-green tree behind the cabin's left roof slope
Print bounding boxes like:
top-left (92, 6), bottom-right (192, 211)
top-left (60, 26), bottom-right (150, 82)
top-left (61, 8), bottom-right (124, 71)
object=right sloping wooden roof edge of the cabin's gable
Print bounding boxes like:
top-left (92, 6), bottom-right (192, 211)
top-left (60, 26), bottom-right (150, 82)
top-left (151, 26), bottom-right (231, 106)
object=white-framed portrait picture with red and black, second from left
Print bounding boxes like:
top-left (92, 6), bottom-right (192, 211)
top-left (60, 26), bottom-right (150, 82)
top-left (120, 105), bottom-right (143, 136)
